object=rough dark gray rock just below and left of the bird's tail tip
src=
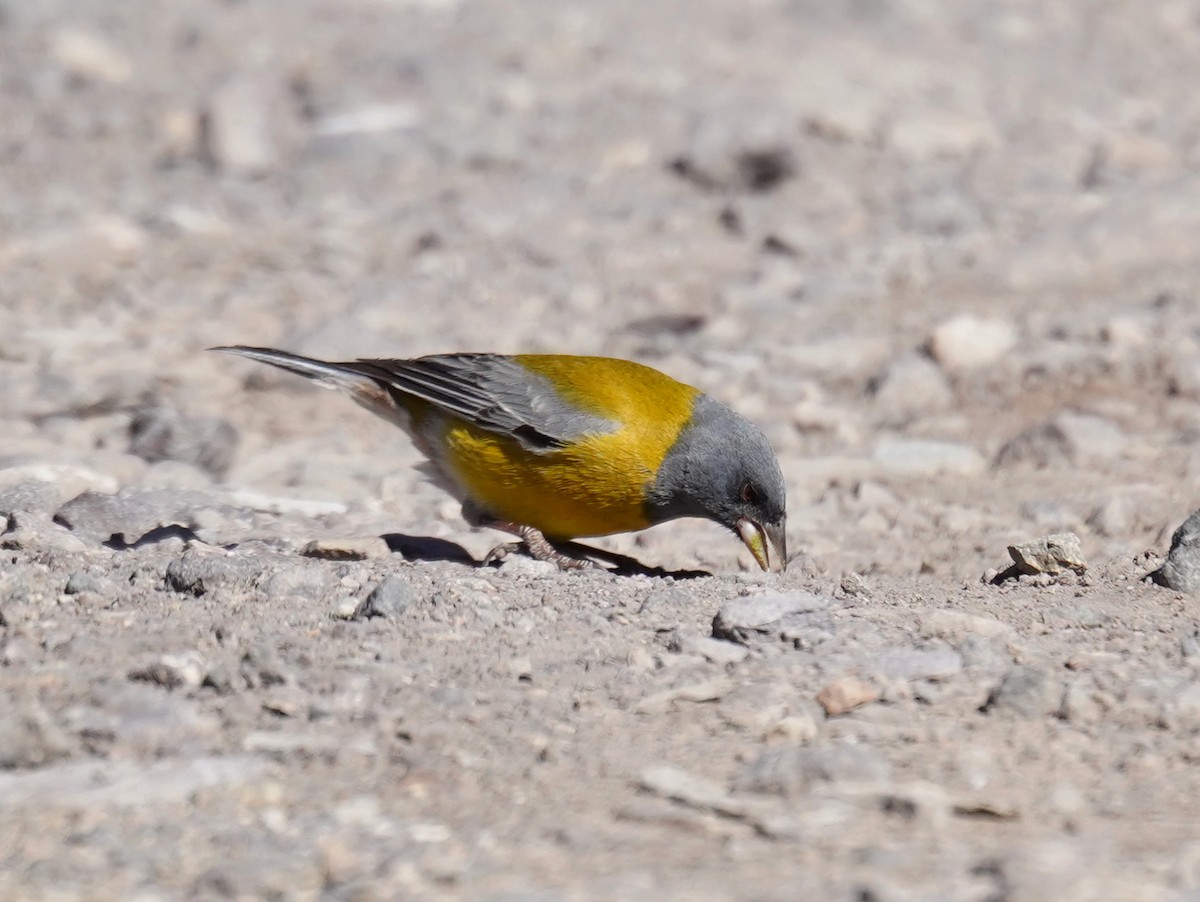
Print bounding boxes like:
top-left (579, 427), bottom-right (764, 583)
top-left (130, 405), bottom-right (238, 479)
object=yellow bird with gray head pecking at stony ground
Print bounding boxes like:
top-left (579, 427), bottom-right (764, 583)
top-left (210, 345), bottom-right (787, 571)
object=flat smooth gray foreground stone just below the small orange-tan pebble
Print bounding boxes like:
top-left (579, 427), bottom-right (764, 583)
top-left (733, 742), bottom-right (892, 795)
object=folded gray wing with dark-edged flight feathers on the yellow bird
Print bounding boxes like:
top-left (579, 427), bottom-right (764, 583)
top-left (340, 354), bottom-right (618, 451)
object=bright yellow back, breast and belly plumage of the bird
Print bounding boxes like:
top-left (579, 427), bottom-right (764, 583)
top-left (442, 355), bottom-right (700, 539)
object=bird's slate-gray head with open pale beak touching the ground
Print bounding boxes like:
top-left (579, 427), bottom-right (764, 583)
top-left (647, 395), bottom-right (787, 570)
